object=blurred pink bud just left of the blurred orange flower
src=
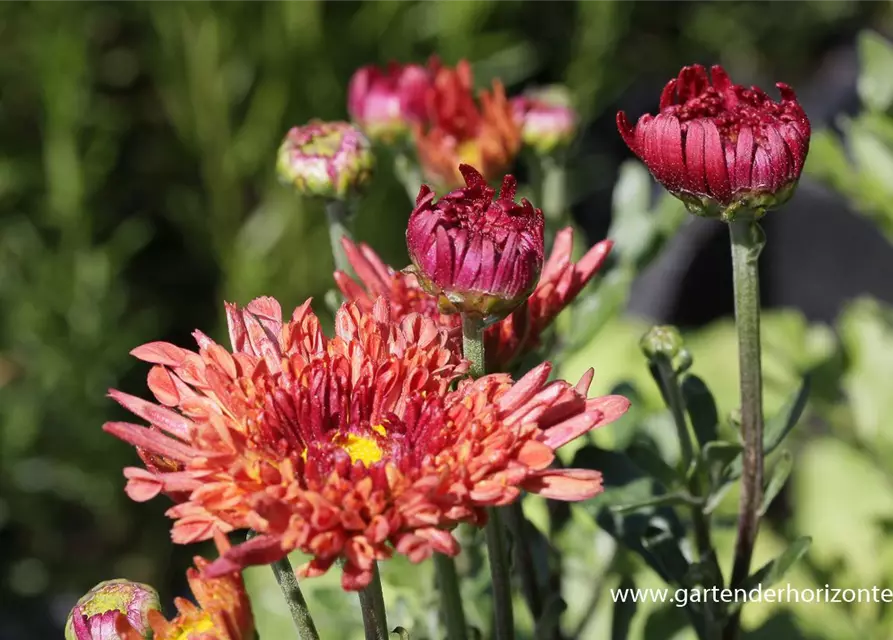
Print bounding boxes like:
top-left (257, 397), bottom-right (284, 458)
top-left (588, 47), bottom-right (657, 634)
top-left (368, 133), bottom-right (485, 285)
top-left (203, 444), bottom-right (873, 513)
top-left (347, 60), bottom-right (436, 142)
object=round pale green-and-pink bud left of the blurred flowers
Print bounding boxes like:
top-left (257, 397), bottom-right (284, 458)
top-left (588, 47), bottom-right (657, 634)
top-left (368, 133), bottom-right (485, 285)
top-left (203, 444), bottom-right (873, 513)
top-left (276, 120), bottom-right (375, 200)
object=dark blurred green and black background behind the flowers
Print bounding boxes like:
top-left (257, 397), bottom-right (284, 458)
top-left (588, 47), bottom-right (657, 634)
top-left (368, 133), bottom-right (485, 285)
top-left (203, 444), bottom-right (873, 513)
top-left (0, 0), bottom-right (893, 640)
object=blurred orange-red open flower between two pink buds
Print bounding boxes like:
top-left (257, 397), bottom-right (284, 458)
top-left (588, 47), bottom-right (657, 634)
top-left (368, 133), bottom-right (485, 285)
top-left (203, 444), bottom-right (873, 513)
top-left (415, 60), bottom-right (521, 189)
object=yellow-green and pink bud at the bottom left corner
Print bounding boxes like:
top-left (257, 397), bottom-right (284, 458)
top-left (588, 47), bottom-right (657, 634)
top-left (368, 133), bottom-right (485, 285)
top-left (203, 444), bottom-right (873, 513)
top-left (65, 579), bottom-right (161, 640)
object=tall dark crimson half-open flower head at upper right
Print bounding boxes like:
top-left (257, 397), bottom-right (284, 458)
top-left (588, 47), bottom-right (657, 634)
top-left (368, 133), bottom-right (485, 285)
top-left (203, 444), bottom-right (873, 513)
top-left (617, 65), bottom-right (810, 219)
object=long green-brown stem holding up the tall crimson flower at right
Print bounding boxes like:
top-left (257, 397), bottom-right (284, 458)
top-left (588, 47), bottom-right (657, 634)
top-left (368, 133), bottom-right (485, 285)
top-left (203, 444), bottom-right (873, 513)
top-left (724, 217), bottom-right (765, 640)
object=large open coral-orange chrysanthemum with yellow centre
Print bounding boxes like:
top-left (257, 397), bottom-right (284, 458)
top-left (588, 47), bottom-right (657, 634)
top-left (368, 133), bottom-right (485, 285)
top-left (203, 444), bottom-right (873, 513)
top-left (104, 298), bottom-right (628, 590)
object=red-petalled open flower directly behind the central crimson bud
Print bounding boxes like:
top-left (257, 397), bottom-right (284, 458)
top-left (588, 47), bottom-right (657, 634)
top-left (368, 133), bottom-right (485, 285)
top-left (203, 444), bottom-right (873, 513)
top-left (335, 227), bottom-right (613, 371)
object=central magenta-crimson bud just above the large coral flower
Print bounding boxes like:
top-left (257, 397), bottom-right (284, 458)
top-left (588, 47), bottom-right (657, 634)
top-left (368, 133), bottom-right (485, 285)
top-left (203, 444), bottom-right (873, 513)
top-left (406, 164), bottom-right (543, 321)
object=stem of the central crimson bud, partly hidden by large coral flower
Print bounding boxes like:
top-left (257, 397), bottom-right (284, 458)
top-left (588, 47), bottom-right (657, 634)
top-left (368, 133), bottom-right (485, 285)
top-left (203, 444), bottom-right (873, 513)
top-left (462, 313), bottom-right (515, 640)
